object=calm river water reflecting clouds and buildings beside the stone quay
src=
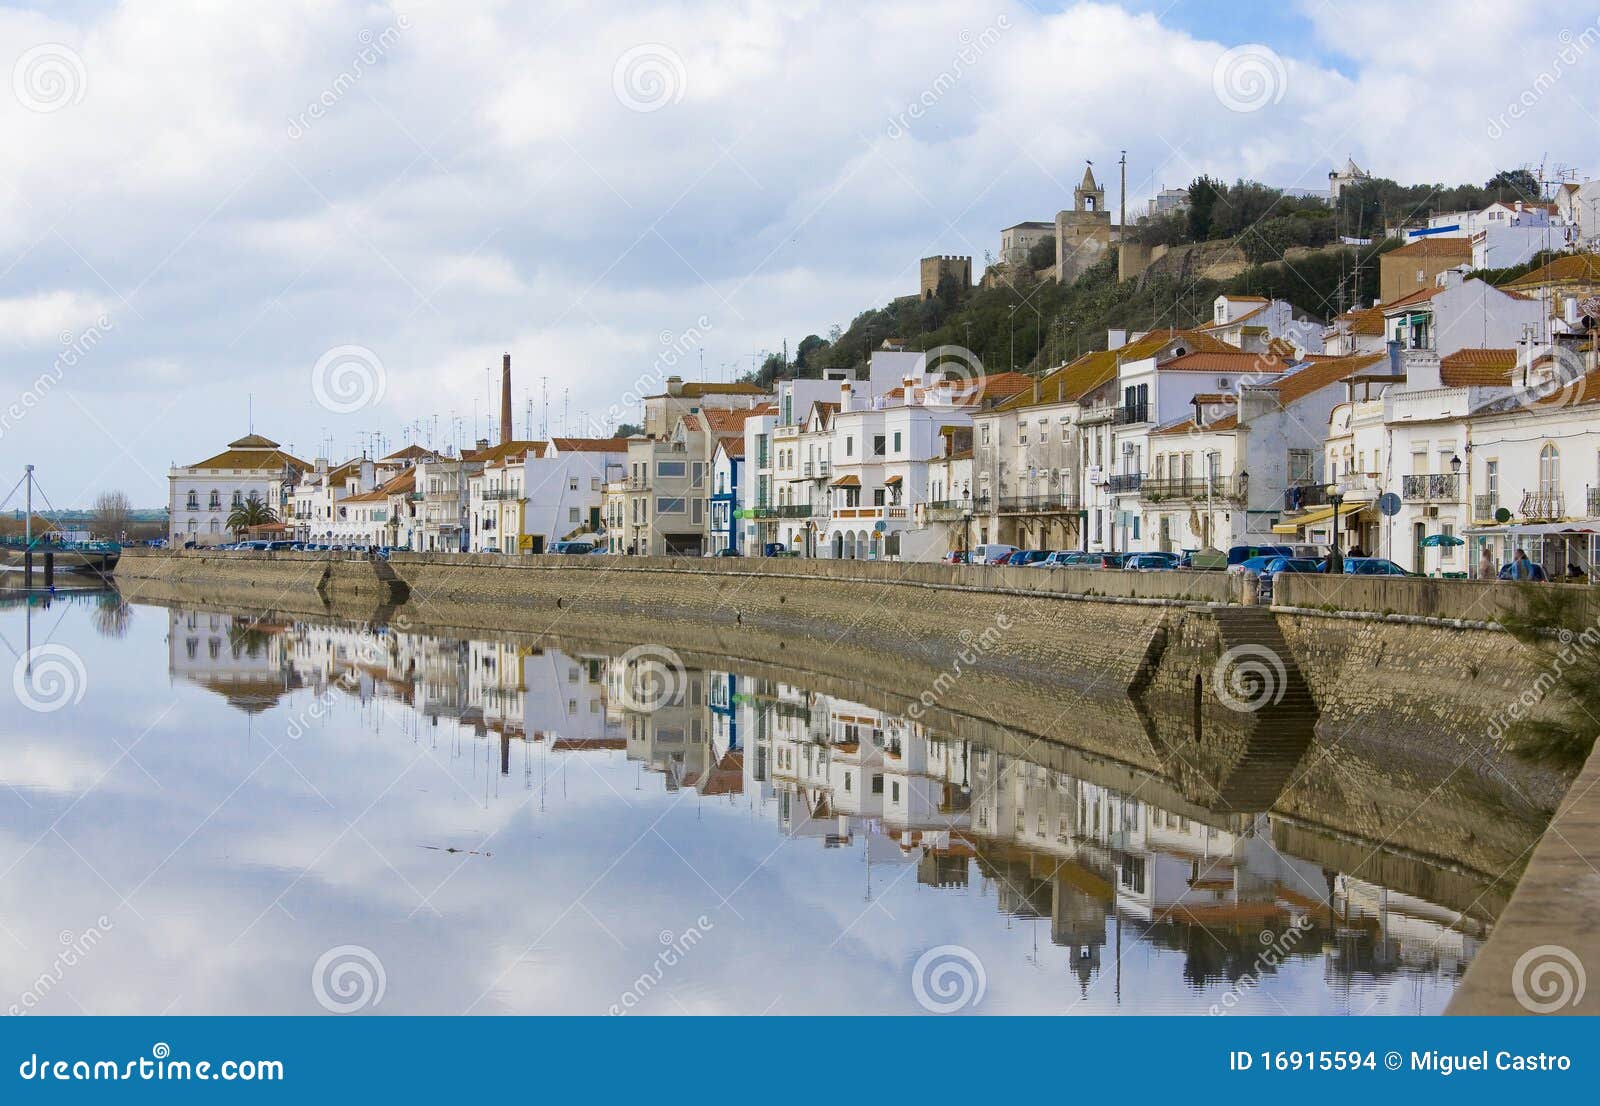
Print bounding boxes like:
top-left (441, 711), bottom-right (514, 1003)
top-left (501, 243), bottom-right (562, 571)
top-left (0, 599), bottom-right (1488, 1013)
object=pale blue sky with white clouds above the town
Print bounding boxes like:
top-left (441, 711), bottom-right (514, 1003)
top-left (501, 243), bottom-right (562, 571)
top-left (0, 0), bottom-right (1600, 506)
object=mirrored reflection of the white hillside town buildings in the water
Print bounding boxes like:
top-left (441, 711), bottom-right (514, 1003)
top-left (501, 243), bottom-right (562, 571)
top-left (170, 611), bottom-right (1486, 991)
